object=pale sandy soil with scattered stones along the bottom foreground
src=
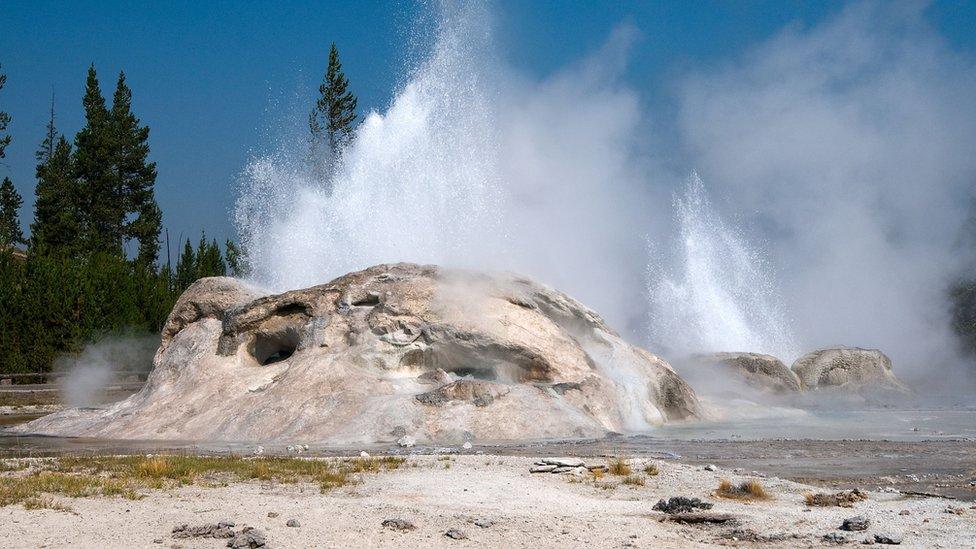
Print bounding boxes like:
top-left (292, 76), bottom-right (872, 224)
top-left (0, 455), bottom-right (976, 548)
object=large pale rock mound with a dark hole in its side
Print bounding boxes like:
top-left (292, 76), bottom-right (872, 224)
top-left (18, 264), bottom-right (701, 444)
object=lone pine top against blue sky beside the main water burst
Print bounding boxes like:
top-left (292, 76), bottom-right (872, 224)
top-left (308, 43), bottom-right (357, 155)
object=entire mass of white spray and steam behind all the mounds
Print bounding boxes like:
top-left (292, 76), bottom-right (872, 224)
top-left (236, 3), bottom-right (976, 386)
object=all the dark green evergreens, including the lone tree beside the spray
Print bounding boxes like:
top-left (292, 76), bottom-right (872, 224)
top-left (0, 45), bottom-right (356, 374)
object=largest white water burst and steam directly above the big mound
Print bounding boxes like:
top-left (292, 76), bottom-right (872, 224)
top-left (236, 6), bottom-right (649, 334)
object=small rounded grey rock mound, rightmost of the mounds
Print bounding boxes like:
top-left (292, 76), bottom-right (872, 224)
top-left (793, 347), bottom-right (908, 393)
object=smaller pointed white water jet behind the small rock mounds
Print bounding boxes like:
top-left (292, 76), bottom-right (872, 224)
top-left (648, 174), bottom-right (798, 361)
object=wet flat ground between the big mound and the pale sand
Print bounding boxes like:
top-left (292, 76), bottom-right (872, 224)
top-left (0, 409), bottom-right (976, 501)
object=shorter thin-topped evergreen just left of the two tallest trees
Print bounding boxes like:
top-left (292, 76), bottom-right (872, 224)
top-left (31, 99), bottom-right (79, 254)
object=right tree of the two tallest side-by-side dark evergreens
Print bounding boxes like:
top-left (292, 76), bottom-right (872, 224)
top-left (110, 72), bottom-right (162, 266)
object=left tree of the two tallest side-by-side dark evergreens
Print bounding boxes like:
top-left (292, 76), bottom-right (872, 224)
top-left (73, 65), bottom-right (126, 256)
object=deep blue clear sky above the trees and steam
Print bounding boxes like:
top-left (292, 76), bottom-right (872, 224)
top-left (0, 0), bottom-right (976, 253)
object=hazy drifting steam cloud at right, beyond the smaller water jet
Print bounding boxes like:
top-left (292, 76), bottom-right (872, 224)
top-left (681, 2), bottom-right (976, 384)
